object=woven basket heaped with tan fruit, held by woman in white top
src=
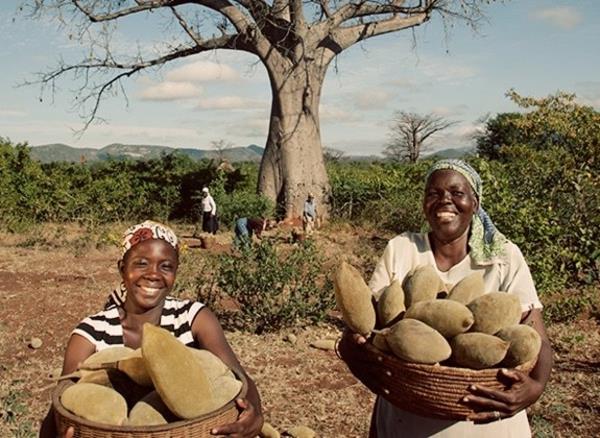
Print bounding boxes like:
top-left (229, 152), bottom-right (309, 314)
top-left (334, 263), bottom-right (541, 420)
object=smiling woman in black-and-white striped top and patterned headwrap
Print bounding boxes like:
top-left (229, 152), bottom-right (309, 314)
top-left (40, 221), bottom-right (263, 437)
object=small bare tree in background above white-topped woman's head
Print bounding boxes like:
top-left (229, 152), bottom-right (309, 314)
top-left (383, 111), bottom-right (457, 163)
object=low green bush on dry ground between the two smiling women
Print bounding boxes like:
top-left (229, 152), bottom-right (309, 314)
top-left (197, 239), bottom-right (335, 333)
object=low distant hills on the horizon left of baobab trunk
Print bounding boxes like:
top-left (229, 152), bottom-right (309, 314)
top-left (31, 143), bottom-right (264, 163)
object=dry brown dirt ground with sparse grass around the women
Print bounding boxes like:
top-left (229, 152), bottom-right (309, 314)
top-left (0, 227), bottom-right (600, 438)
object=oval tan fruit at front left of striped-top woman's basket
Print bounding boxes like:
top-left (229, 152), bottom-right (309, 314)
top-left (60, 383), bottom-right (127, 426)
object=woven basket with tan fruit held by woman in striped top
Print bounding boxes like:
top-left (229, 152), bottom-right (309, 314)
top-left (52, 324), bottom-right (247, 438)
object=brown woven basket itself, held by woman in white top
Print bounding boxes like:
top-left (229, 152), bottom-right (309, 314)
top-left (337, 332), bottom-right (535, 420)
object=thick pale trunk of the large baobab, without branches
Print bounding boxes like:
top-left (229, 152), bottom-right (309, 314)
top-left (258, 64), bottom-right (331, 219)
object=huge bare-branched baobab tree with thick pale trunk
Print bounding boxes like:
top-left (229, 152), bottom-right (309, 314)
top-left (28, 0), bottom-right (490, 217)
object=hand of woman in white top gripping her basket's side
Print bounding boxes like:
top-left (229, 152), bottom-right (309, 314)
top-left (463, 369), bottom-right (544, 423)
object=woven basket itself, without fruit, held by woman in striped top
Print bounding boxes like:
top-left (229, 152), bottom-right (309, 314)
top-left (52, 373), bottom-right (248, 438)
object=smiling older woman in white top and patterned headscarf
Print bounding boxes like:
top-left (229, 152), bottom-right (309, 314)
top-left (366, 160), bottom-right (552, 438)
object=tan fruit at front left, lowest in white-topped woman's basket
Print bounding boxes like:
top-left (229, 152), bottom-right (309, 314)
top-left (384, 318), bottom-right (452, 364)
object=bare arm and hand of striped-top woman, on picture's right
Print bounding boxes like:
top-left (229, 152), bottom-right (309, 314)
top-left (192, 308), bottom-right (263, 438)
